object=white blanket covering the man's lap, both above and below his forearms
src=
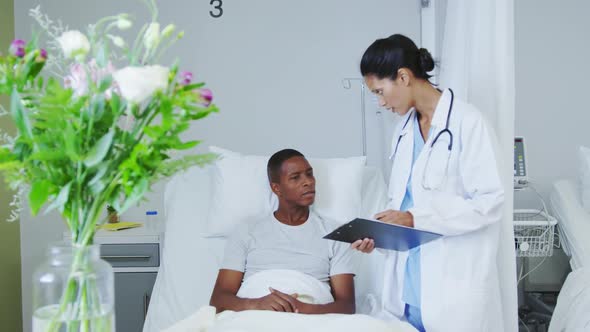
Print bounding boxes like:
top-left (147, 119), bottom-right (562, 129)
top-left (165, 270), bottom-right (415, 332)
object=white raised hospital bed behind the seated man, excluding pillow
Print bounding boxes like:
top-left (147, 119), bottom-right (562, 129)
top-left (143, 160), bottom-right (414, 332)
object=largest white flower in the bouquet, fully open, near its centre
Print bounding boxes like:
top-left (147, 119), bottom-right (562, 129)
top-left (113, 65), bottom-right (169, 104)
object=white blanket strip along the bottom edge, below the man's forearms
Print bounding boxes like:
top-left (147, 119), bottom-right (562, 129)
top-left (165, 306), bottom-right (416, 332)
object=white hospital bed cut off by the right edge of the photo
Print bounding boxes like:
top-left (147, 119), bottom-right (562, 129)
top-left (549, 180), bottom-right (590, 331)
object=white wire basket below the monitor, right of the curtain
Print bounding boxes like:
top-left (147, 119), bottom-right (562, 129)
top-left (514, 209), bottom-right (557, 257)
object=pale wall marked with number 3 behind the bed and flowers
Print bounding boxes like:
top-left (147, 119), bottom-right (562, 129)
top-left (15, 0), bottom-right (420, 331)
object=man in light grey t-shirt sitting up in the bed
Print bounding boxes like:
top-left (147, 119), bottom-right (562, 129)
top-left (210, 149), bottom-right (355, 314)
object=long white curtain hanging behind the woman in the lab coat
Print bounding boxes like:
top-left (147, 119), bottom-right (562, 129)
top-left (439, 0), bottom-right (518, 331)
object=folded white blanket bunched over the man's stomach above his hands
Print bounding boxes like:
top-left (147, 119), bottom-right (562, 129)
top-left (237, 270), bottom-right (334, 304)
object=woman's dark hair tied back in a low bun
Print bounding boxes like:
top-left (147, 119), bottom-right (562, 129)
top-left (361, 34), bottom-right (434, 81)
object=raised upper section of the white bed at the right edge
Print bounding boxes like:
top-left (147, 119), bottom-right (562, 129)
top-left (550, 180), bottom-right (590, 270)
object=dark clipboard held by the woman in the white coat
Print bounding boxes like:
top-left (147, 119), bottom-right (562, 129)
top-left (324, 218), bottom-right (442, 251)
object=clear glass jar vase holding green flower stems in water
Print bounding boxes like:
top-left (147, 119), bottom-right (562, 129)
top-left (33, 244), bottom-right (115, 332)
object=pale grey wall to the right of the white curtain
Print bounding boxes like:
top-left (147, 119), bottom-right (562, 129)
top-left (514, 0), bottom-right (590, 288)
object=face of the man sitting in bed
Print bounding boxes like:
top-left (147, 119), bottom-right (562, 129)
top-left (273, 157), bottom-right (315, 206)
